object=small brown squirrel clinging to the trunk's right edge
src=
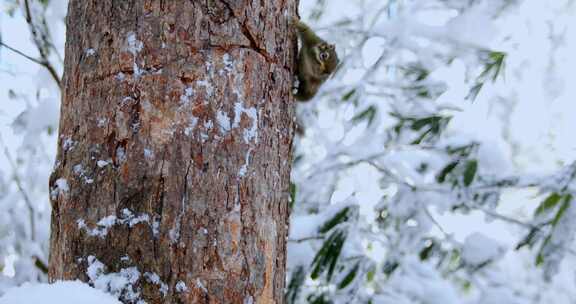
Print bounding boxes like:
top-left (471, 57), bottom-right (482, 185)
top-left (292, 18), bottom-right (339, 101)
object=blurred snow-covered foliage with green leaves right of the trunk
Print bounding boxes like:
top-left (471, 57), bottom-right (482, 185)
top-left (286, 0), bottom-right (576, 304)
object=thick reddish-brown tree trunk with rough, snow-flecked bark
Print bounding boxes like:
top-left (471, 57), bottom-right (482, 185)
top-left (49, 0), bottom-right (297, 303)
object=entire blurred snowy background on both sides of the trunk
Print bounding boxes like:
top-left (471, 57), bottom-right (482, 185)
top-left (0, 0), bottom-right (576, 304)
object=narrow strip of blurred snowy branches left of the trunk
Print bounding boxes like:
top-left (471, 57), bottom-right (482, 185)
top-left (0, 0), bottom-right (67, 294)
